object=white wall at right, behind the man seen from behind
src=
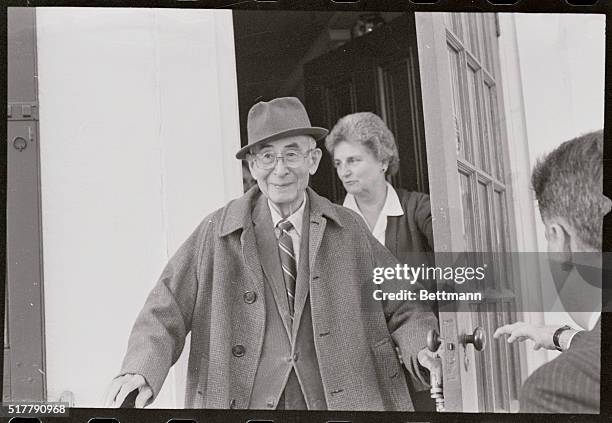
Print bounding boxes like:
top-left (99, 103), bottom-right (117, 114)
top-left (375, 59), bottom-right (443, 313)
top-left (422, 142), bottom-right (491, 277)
top-left (514, 14), bottom-right (605, 364)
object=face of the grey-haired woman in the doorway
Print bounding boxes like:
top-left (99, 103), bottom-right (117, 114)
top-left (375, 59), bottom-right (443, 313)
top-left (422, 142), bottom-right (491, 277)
top-left (334, 141), bottom-right (386, 197)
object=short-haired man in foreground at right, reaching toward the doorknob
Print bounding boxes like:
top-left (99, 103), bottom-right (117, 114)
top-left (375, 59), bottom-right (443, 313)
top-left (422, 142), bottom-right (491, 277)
top-left (494, 131), bottom-right (610, 413)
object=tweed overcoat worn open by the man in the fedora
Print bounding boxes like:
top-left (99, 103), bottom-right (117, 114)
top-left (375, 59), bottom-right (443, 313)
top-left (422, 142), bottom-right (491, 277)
top-left (121, 187), bottom-right (437, 410)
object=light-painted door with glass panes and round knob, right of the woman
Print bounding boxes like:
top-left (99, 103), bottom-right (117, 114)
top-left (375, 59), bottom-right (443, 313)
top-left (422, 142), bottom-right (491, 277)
top-left (415, 13), bottom-right (521, 412)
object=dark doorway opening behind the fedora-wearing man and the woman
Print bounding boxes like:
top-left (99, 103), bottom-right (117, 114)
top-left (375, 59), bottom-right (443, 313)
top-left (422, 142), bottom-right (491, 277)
top-left (234, 11), bottom-right (429, 204)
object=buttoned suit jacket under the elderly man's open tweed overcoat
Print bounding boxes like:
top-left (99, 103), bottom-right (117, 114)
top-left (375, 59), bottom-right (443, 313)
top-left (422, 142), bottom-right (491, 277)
top-left (248, 195), bottom-right (327, 410)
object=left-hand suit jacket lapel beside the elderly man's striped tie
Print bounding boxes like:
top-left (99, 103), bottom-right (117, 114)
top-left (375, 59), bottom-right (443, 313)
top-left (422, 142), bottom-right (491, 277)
top-left (253, 195), bottom-right (292, 339)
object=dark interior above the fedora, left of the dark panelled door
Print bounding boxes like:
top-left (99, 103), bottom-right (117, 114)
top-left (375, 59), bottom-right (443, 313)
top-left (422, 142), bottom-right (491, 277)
top-left (233, 10), bottom-right (402, 146)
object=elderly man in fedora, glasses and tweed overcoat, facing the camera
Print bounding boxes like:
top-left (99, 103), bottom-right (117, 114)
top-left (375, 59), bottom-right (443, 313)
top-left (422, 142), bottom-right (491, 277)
top-left (106, 98), bottom-right (437, 410)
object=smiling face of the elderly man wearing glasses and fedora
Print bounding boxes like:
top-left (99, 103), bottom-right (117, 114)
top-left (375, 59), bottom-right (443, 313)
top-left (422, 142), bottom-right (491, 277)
top-left (249, 136), bottom-right (321, 216)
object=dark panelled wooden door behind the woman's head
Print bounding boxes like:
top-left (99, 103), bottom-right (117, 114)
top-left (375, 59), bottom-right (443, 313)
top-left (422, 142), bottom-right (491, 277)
top-left (304, 14), bottom-right (429, 203)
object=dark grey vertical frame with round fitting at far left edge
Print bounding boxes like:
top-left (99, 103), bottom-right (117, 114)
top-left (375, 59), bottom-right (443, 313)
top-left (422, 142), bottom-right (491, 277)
top-left (2, 7), bottom-right (47, 401)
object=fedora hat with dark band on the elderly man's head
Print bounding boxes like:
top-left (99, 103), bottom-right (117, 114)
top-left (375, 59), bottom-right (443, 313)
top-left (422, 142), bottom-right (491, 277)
top-left (236, 97), bottom-right (329, 160)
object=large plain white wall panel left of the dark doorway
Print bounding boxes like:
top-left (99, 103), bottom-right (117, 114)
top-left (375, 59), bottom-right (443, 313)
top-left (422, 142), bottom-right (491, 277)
top-left (37, 8), bottom-right (242, 407)
